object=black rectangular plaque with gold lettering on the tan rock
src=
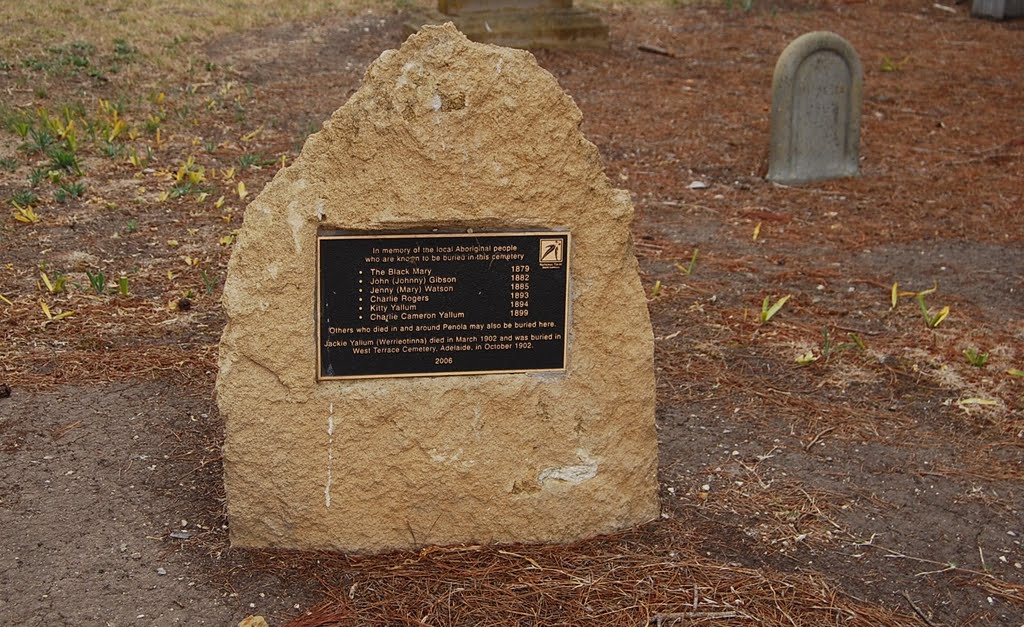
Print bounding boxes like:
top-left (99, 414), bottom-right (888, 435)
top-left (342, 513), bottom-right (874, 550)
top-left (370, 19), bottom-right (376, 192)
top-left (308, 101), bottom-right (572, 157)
top-left (316, 232), bottom-right (569, 380)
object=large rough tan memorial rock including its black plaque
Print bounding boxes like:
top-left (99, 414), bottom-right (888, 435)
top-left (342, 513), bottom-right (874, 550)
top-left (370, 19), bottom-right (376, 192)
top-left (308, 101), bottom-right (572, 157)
top-left (217, 25), bottom-right (658, 551)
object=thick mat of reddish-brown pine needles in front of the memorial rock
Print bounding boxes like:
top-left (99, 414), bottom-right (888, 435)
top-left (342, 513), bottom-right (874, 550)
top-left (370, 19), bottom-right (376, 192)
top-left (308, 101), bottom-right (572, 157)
top-left (276, 520), bottom-right (916, 627)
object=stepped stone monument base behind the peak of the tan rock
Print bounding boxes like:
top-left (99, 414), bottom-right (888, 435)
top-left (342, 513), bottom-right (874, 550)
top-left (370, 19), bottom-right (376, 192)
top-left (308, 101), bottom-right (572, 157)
top-left (404, 8), bottom-right (608, 49)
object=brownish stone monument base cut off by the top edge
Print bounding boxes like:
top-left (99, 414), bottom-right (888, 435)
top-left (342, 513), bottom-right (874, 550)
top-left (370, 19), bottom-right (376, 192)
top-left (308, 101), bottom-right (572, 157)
top-left (406, 0), bottom-right (608, 48)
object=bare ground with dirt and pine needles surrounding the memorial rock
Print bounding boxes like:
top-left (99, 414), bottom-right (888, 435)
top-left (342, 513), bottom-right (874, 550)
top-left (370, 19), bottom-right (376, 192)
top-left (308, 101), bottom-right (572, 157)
top-left (0, 0), bottom-right (1024, 626)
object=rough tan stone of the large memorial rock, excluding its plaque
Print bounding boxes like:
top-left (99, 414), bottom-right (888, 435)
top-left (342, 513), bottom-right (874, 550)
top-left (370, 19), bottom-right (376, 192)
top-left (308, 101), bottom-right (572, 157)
top-left (217, 25), bottom-right (658, 551)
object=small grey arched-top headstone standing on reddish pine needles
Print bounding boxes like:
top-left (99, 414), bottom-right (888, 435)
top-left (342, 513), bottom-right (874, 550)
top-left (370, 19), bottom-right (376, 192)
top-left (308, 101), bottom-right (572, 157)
top-left (768, 31), bottom-right (864, 184)
